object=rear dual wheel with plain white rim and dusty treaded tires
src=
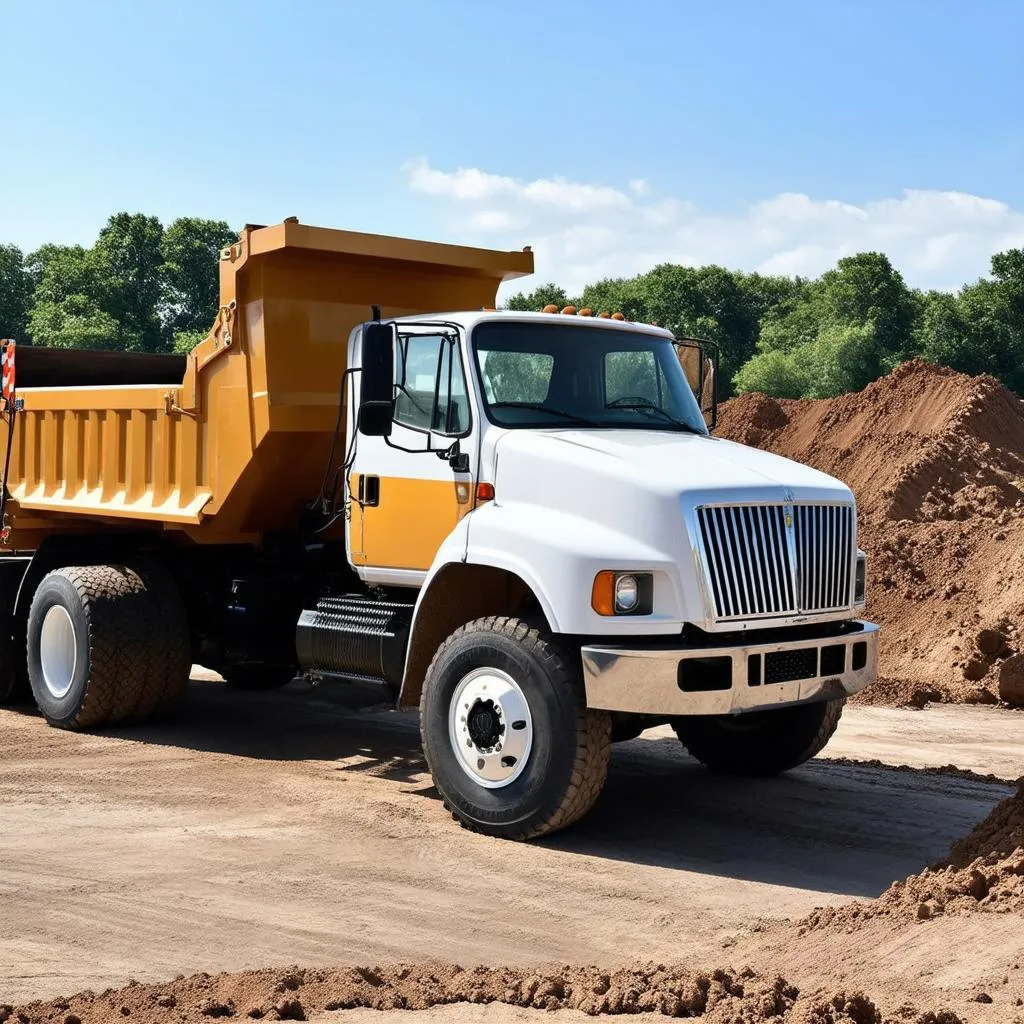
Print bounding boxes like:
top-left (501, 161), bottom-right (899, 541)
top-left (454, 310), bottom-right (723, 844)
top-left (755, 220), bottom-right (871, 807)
top-left (28, 564), bottom-right (191, 729)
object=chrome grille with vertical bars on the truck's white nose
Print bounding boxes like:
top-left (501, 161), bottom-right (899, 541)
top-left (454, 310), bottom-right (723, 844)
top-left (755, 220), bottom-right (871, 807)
top-left (697, 505), bottom-right (854, 620)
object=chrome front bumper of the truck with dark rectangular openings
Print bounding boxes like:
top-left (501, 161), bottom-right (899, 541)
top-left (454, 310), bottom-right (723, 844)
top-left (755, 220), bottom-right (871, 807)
top-left (582, 620), bottom-right (879, 716)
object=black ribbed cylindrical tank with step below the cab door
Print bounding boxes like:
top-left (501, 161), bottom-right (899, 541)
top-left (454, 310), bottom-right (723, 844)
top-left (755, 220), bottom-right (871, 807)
top-left (295, 594), bottom-right (414, 685)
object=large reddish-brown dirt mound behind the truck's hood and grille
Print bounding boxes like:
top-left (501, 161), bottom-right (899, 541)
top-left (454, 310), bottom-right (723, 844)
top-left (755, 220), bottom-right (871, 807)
top-left (717, 359), bottom-right (1024, 706)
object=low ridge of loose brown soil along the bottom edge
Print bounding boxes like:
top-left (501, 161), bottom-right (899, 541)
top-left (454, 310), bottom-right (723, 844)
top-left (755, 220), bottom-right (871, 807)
top-left (0, 965), bottom-right (962, 1024)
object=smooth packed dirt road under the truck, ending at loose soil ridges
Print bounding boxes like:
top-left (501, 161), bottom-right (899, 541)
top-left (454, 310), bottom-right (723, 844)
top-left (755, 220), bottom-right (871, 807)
top-left (0, 682), bottom-right (1024, 1001)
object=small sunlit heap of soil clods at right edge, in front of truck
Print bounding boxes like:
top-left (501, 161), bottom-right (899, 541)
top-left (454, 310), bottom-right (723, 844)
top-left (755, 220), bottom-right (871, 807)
top-left (799, 779), bottom-right (1024, 934)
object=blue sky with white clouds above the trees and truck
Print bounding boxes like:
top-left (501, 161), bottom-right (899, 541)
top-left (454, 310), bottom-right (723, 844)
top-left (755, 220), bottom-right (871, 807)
top-left (0, 0), bottom-right (1024, 287)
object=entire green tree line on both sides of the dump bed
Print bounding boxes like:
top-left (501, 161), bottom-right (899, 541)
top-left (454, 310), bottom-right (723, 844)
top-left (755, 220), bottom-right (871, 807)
top-left (0, 213), bottom-right (1024, 398)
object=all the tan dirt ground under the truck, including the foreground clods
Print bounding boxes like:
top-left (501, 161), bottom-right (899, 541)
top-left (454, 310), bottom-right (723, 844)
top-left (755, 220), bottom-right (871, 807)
top-left (0, 683), bottom-right (1024, 1024)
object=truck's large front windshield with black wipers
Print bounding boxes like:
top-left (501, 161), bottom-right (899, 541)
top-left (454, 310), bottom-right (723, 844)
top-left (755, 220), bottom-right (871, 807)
top-left (473, 321), bottom-right (708, 434)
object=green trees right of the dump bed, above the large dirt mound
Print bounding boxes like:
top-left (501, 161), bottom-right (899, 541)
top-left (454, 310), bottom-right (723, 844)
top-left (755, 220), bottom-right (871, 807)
top-left (508, 249), bottom-right (1024, 398)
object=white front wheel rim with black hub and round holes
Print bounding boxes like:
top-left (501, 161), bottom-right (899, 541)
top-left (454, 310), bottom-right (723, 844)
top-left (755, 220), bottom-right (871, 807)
top-left (449, 669), bottom-right (534, 790)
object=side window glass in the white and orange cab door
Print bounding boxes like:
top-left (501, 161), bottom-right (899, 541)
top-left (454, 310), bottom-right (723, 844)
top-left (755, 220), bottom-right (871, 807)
top-left (394, 334), bottom-right (469, 436)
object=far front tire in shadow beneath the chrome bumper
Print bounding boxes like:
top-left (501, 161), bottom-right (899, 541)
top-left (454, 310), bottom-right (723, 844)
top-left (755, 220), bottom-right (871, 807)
top-left (672, 698), bottom-right (846, 775)
